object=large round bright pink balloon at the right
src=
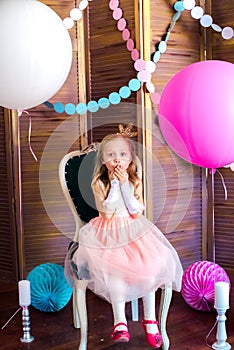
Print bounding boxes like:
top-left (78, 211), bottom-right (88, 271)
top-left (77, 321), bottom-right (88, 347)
top-left (159, 60), bottom-right (234, 169)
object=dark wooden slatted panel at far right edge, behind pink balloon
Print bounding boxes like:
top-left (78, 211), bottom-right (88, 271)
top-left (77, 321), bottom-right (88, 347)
top-left (211, 0), bottom-right (234, 270)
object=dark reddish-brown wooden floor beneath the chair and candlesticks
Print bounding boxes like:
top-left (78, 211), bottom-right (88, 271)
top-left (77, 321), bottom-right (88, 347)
top-left (0, 284), bottom-right (234, 350)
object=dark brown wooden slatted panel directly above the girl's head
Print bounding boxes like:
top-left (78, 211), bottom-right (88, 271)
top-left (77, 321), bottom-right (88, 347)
top-left (89, 0), bottom-right (137, 141)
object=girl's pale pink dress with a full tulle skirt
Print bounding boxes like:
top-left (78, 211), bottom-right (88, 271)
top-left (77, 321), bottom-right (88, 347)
top-left (66, 183), bottom-right (183, 302)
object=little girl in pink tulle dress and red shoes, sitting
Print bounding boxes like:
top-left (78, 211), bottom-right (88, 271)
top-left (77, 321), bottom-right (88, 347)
top-left (67, 131), bottom-right (183, 348)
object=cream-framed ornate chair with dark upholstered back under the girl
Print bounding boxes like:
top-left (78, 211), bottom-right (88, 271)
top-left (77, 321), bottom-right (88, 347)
top-left (59, 143), bottom-right (172, 350)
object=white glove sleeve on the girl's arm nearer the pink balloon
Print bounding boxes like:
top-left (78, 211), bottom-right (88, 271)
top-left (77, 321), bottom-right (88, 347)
top-left (120, 180), bottom-right (143, 214)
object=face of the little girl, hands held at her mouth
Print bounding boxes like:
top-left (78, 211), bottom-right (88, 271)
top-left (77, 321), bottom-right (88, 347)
top-left (102, 139), bottom-right (132, 171)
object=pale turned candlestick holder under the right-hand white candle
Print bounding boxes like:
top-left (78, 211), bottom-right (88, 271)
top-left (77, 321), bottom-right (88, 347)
top-left (212, 306), bottom-right (232, 350)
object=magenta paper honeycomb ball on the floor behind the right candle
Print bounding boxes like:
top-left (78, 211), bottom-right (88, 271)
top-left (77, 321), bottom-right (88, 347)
top-left (181, 261), bottom-right (230, 311)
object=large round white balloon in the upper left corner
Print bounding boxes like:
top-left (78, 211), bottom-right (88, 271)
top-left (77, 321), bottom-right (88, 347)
top-left (0, 0), bottom-right (72, 110)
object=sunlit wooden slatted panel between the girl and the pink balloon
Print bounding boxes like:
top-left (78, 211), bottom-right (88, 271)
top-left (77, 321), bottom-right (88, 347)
top-left (150, 0), bottom-right (202, 268)
